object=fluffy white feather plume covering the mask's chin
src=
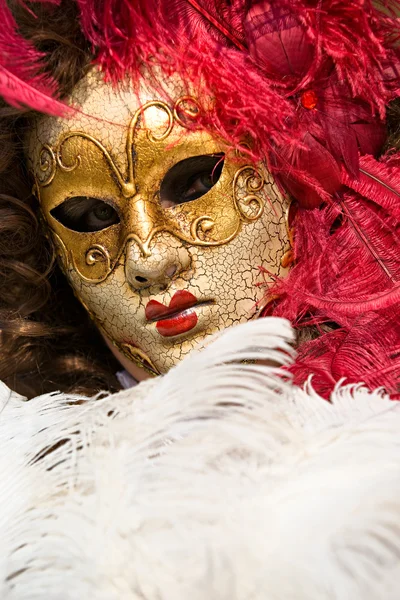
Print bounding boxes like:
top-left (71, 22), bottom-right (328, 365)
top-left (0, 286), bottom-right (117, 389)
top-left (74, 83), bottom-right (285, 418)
top-left (0, 318), bottom-right (400, 600)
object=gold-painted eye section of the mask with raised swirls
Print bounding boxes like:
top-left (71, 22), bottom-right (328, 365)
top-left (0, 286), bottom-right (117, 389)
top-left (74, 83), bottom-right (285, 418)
top-left (36, 96), bottom-right (266, 283)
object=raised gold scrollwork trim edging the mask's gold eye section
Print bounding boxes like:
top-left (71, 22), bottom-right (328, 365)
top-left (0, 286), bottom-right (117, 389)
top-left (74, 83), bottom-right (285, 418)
top-left (37, 96), bottom-right (265, 283)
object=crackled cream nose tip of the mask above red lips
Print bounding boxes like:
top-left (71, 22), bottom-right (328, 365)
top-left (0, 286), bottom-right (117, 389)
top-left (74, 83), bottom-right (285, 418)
top-left (125, 234), bottom-right (190, 291)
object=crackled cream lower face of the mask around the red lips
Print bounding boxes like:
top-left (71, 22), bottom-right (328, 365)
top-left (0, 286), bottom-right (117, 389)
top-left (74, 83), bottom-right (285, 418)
top-left (70, 192), bottom-right (287, 373)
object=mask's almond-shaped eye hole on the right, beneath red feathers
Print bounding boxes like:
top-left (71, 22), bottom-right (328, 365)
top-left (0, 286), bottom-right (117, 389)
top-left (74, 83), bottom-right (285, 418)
top-left (160, 154), bottom-right (225, 208)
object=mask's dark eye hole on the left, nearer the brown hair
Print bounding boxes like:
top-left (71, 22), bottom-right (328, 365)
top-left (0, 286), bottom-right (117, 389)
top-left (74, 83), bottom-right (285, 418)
top-left (50, 196), bottom-right (120, 232)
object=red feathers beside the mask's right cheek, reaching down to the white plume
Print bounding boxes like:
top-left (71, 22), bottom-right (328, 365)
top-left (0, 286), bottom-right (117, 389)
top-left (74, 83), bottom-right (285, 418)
top-left (268, 193), bottom-right (400, 397)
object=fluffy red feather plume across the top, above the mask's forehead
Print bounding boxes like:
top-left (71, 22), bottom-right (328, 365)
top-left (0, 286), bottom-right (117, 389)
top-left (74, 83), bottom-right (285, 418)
top-left (72, 0), bottom-right (400, 208)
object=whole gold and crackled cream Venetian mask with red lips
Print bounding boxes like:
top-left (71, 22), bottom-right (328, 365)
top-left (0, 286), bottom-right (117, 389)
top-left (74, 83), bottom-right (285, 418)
top-left (28, 71), bottom-right (289, 373)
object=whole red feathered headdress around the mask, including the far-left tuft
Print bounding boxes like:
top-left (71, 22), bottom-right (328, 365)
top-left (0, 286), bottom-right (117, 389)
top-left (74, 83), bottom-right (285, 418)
top-left (0, 0), bottom-right (400, 398)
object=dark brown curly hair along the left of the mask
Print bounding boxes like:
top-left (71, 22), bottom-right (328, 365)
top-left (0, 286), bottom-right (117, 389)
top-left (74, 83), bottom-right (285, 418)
top-left (0, 0), bottom-right (119, 397)
